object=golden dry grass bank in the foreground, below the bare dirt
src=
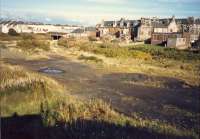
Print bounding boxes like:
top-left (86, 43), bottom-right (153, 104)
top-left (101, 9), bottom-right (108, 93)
top-left (0, 63), bottom-right (197, 139)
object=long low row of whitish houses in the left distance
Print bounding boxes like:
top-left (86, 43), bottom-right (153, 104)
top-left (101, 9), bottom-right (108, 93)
top-left (0, 20), bottom-right (96, 39)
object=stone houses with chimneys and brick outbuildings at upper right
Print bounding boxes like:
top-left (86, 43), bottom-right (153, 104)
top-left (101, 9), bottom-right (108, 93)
top-left (96, 16), bottom-right (200, 49)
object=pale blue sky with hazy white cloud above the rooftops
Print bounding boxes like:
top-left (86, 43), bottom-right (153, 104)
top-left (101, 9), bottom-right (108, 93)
top-left (0, 0), bottom-right (200, 24)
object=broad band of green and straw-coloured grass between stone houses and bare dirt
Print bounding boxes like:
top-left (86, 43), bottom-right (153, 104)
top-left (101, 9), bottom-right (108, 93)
top-left (76, 42), bottom-right (200, 87)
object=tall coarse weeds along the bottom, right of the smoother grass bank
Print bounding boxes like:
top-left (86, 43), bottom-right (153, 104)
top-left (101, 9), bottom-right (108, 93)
top-left (41, 100), bottom-right (198, 139)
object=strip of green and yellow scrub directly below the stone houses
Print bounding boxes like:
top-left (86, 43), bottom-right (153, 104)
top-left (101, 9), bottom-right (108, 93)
top-left (78, 43), bottom-right (200, 61)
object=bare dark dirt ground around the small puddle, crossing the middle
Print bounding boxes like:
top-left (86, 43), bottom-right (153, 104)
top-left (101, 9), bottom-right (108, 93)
top-left (2, 47), bottom-right (200, 131)
